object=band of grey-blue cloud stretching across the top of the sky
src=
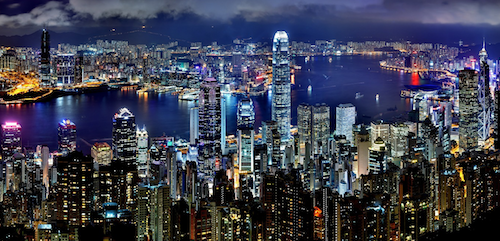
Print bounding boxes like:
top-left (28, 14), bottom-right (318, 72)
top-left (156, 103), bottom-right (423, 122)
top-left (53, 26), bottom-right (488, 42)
top-left (0, 0), bottom-right (500, 35)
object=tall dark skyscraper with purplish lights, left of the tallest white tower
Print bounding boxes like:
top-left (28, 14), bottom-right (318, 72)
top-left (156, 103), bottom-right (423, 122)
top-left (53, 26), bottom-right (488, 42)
top-left (198, 78), bottom-right (222, 171)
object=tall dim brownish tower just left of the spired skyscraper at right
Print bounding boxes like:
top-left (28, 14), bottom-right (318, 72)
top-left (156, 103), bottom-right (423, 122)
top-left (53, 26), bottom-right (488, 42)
top-left (458, 69), bottom-right (480, 150)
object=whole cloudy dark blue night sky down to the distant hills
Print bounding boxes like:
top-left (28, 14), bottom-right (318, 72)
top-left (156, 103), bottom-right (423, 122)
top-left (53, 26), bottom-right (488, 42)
top-left (0, 0), bottom-right (500, 44)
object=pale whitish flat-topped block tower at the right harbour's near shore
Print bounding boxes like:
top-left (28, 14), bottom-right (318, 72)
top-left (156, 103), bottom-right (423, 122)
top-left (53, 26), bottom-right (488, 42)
top-left (335, 103), bottom-right (356, 144)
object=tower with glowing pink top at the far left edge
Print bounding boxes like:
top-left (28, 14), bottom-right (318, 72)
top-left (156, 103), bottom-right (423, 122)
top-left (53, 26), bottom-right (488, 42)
top-left (2, 122), bottom-right (22, 159)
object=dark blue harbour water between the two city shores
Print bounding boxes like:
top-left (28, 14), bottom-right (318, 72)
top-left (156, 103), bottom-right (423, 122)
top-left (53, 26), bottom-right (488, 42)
top-left (0, 55), bottom-right (424, 153)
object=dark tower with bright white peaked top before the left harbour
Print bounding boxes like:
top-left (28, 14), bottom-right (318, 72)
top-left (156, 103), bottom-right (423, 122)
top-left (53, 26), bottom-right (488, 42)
top-left (113, 108), bottom-right (137, 165)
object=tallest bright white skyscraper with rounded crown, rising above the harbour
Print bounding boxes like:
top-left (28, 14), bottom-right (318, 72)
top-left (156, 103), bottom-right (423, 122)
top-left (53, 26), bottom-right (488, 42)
top-left (271, 31), bottom-right (291, 142)
